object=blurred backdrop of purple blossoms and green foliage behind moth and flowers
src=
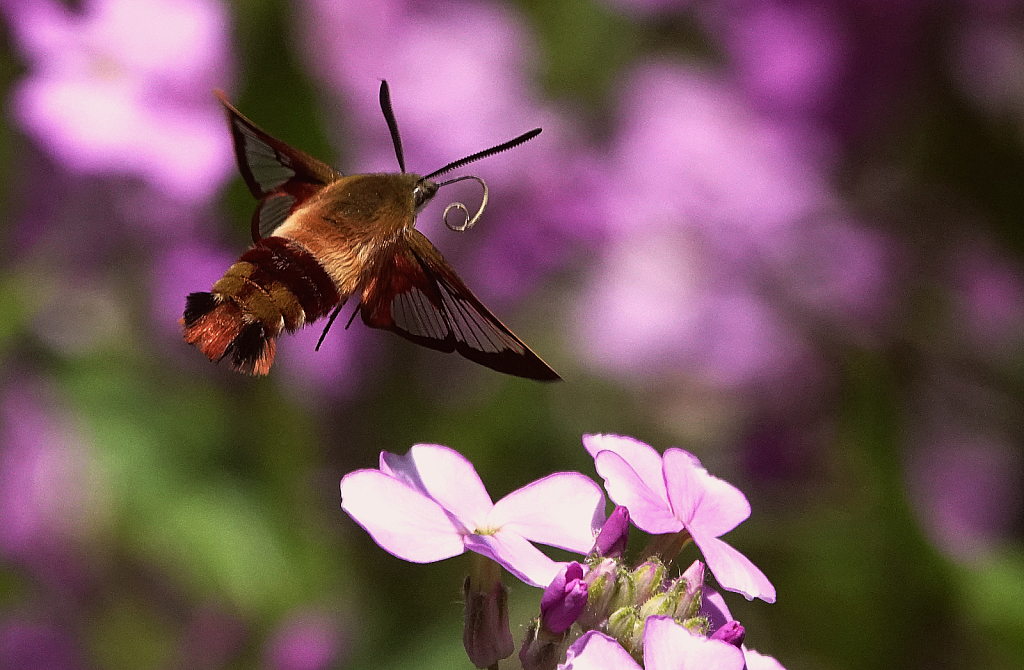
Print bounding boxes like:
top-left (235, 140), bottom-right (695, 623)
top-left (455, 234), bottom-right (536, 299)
top-left (0, 0), bottom-right (1024, 670)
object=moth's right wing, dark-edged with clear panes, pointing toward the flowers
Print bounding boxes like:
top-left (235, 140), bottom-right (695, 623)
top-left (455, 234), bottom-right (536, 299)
top-left (360, 229), bottom-right (560, 381)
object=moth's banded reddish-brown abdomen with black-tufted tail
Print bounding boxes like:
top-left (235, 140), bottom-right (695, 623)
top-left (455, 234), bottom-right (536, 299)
top-left (181, 237), bottom-right (341, 375)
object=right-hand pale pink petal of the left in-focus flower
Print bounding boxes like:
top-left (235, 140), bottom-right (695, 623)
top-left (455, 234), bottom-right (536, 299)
top-left (486, 472), bottom-right (604, 554)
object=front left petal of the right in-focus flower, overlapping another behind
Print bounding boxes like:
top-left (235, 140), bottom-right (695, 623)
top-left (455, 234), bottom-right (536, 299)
top-left (594, 451), bottom-right (683, 534)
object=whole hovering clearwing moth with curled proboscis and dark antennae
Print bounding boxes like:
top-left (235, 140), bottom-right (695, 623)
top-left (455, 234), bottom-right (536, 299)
top-left (181, 82), bottom-right (559, 381)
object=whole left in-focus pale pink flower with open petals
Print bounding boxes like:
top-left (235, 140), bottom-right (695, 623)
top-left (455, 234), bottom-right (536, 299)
top-left (341, 445), bottom-right (604, 586)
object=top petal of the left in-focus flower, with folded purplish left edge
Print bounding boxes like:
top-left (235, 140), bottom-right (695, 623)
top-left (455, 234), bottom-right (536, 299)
top-left (381, 445), bottom-right (494, 532)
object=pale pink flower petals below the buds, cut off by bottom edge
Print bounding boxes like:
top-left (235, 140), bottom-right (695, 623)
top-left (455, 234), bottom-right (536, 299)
top-left (558, 617), bottom-right (743, 670)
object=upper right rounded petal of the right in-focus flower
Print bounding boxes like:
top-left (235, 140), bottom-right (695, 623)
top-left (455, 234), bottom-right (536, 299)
top-left (659, 449), bottom-right (751, 537)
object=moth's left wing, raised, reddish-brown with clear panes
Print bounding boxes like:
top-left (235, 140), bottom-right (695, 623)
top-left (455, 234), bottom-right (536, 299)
top-left (216, 91), bottom-right (341, 242)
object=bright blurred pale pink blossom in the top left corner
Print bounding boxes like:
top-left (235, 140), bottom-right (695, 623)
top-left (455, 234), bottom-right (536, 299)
top-left (0, 0), bottom-right (231, 201)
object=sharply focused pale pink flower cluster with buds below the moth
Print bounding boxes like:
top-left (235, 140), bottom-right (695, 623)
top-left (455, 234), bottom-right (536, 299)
top-left (341, 434), bottom-right (781, 670)
